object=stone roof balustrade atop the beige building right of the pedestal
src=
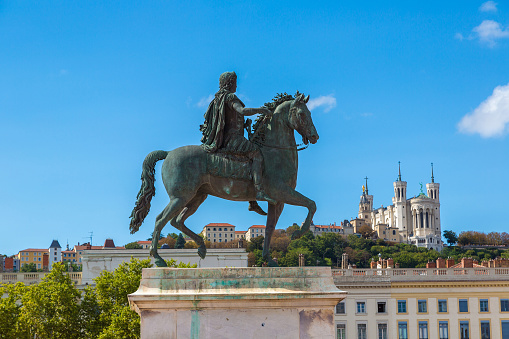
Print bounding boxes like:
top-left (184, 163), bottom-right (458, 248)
top-left (332, 267), bottom-right (509, 283)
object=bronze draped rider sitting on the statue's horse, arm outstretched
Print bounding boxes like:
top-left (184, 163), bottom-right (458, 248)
top-left (200, 72), bottom-right (276, 207)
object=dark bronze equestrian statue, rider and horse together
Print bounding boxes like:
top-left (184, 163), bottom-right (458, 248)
top-left (130, 72), bottom-right (318, 267)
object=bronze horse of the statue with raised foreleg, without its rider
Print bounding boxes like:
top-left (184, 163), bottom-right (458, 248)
top-left (130, 94), bottom-right (318, 267)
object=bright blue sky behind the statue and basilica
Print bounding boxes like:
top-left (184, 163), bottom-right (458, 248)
top-left (0, 1), bottom-right (509, 254)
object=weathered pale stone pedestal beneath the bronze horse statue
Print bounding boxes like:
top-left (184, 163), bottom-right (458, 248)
top-left (129, 267), bottom-right (346, 339)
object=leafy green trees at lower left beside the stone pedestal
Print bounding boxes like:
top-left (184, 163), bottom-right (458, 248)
top-left (0, 258), bottom-right (197, 339)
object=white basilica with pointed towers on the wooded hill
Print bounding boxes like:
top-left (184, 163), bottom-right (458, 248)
top-left (351, 163), bottom-right (443, 251)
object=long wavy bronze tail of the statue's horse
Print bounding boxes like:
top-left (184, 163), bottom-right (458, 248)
top-left (129, 151), bottom-right (168, 234)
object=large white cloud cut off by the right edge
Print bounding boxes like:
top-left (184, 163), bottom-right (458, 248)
top-left (458, 84), bottom-right (509, 138)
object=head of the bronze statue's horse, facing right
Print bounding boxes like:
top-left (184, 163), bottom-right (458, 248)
top-left (288, 94), bottom-right (319, 145)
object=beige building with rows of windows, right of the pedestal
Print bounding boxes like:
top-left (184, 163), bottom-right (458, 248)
top-left (333, 267), bottom-right (509, 339)
